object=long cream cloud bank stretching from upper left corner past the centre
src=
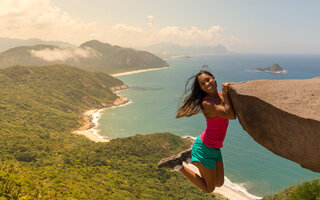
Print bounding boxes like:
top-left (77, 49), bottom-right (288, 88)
top-left (0, 0), bottom-right (238, 47)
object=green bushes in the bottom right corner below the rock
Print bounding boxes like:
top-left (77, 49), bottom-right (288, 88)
top-left (263, 179), bottom-right (320, 200)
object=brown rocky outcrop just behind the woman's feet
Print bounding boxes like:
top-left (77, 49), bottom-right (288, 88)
top-left (158, 148), bottom-right (191, 169)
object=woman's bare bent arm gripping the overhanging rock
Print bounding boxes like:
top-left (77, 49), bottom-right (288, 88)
top-left (202, 83), bottom-right (236, 119)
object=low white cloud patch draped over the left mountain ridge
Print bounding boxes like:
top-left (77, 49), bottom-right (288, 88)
top-left (30, 47), bottom-right (99, 62)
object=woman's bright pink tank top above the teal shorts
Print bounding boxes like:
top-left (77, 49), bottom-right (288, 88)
top-left (200, 97), bottom-right (229, 149)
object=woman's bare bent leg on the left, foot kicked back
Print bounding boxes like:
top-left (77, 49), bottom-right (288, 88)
top-left (180, 162), bottom-right (217, 193)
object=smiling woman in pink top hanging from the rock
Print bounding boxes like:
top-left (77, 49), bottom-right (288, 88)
top-left (158, 70), bottom-right (236, 193)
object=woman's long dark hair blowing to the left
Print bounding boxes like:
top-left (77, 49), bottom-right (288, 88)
top-left (176, 70), bottom-right (215, 118)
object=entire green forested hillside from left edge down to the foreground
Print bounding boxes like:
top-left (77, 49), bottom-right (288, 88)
top-left (0, 65), bottom-right (216, 200)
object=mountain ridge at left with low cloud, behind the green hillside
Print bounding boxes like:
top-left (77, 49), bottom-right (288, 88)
top-left (0, 40), bottom-right (169, 74)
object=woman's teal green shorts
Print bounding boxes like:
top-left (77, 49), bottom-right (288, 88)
top-left (191, 136), bottom-right (222, 169)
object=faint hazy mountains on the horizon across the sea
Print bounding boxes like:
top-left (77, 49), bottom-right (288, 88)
top-left (142, 43), bottom-right (229, 58)
